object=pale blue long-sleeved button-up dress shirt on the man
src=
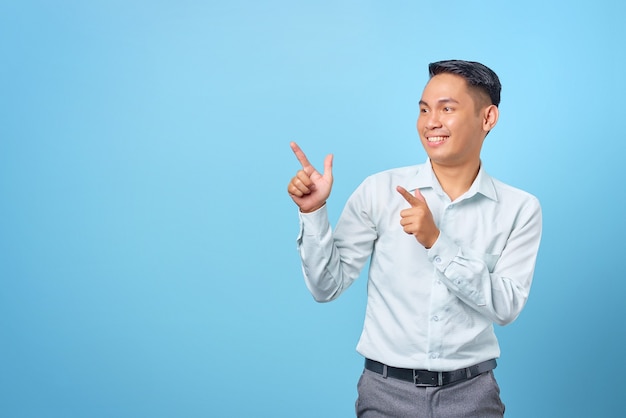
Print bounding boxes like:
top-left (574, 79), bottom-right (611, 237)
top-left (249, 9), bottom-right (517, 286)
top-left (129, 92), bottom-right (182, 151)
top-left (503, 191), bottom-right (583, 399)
top-left (297, 161), bottom-right (541, 371)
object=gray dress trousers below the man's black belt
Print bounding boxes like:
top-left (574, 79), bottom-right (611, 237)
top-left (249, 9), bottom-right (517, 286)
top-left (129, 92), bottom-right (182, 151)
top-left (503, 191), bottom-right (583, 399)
top-left (356, 369), bottom-right (504, 418)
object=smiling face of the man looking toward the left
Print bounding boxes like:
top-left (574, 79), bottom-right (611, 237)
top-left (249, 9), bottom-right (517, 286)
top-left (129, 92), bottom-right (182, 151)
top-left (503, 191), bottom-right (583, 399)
top-left (417, 73), bottom-right (489, 167)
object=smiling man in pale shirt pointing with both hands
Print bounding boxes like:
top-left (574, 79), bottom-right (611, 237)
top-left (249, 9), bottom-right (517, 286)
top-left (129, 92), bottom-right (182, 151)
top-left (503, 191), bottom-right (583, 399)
top-left (288, 60), bottom-right (541, 418)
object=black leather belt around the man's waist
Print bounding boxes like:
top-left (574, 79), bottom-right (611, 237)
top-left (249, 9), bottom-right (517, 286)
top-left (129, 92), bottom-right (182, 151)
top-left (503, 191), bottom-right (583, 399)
top-left (365, 359), bottom-right (498, 386)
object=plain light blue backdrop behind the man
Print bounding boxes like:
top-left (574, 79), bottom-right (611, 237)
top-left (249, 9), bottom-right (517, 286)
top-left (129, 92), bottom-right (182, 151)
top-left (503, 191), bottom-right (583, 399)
top-left (0, 0), bottom-right (626, 418)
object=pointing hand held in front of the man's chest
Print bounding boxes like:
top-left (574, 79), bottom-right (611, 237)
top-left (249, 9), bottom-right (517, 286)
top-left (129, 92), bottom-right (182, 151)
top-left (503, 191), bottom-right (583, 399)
top-left (396, 186), bottom-right (439, 248)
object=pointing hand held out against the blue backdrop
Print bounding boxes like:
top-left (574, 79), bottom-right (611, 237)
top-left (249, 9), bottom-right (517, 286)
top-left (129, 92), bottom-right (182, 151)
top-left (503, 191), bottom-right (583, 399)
top-left (287, 142), bottom-right (333, 213)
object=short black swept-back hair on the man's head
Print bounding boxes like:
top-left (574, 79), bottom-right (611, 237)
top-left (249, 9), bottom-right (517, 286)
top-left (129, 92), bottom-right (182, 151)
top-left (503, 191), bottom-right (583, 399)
top-left (428, 60), bottom-right (502, 106)
